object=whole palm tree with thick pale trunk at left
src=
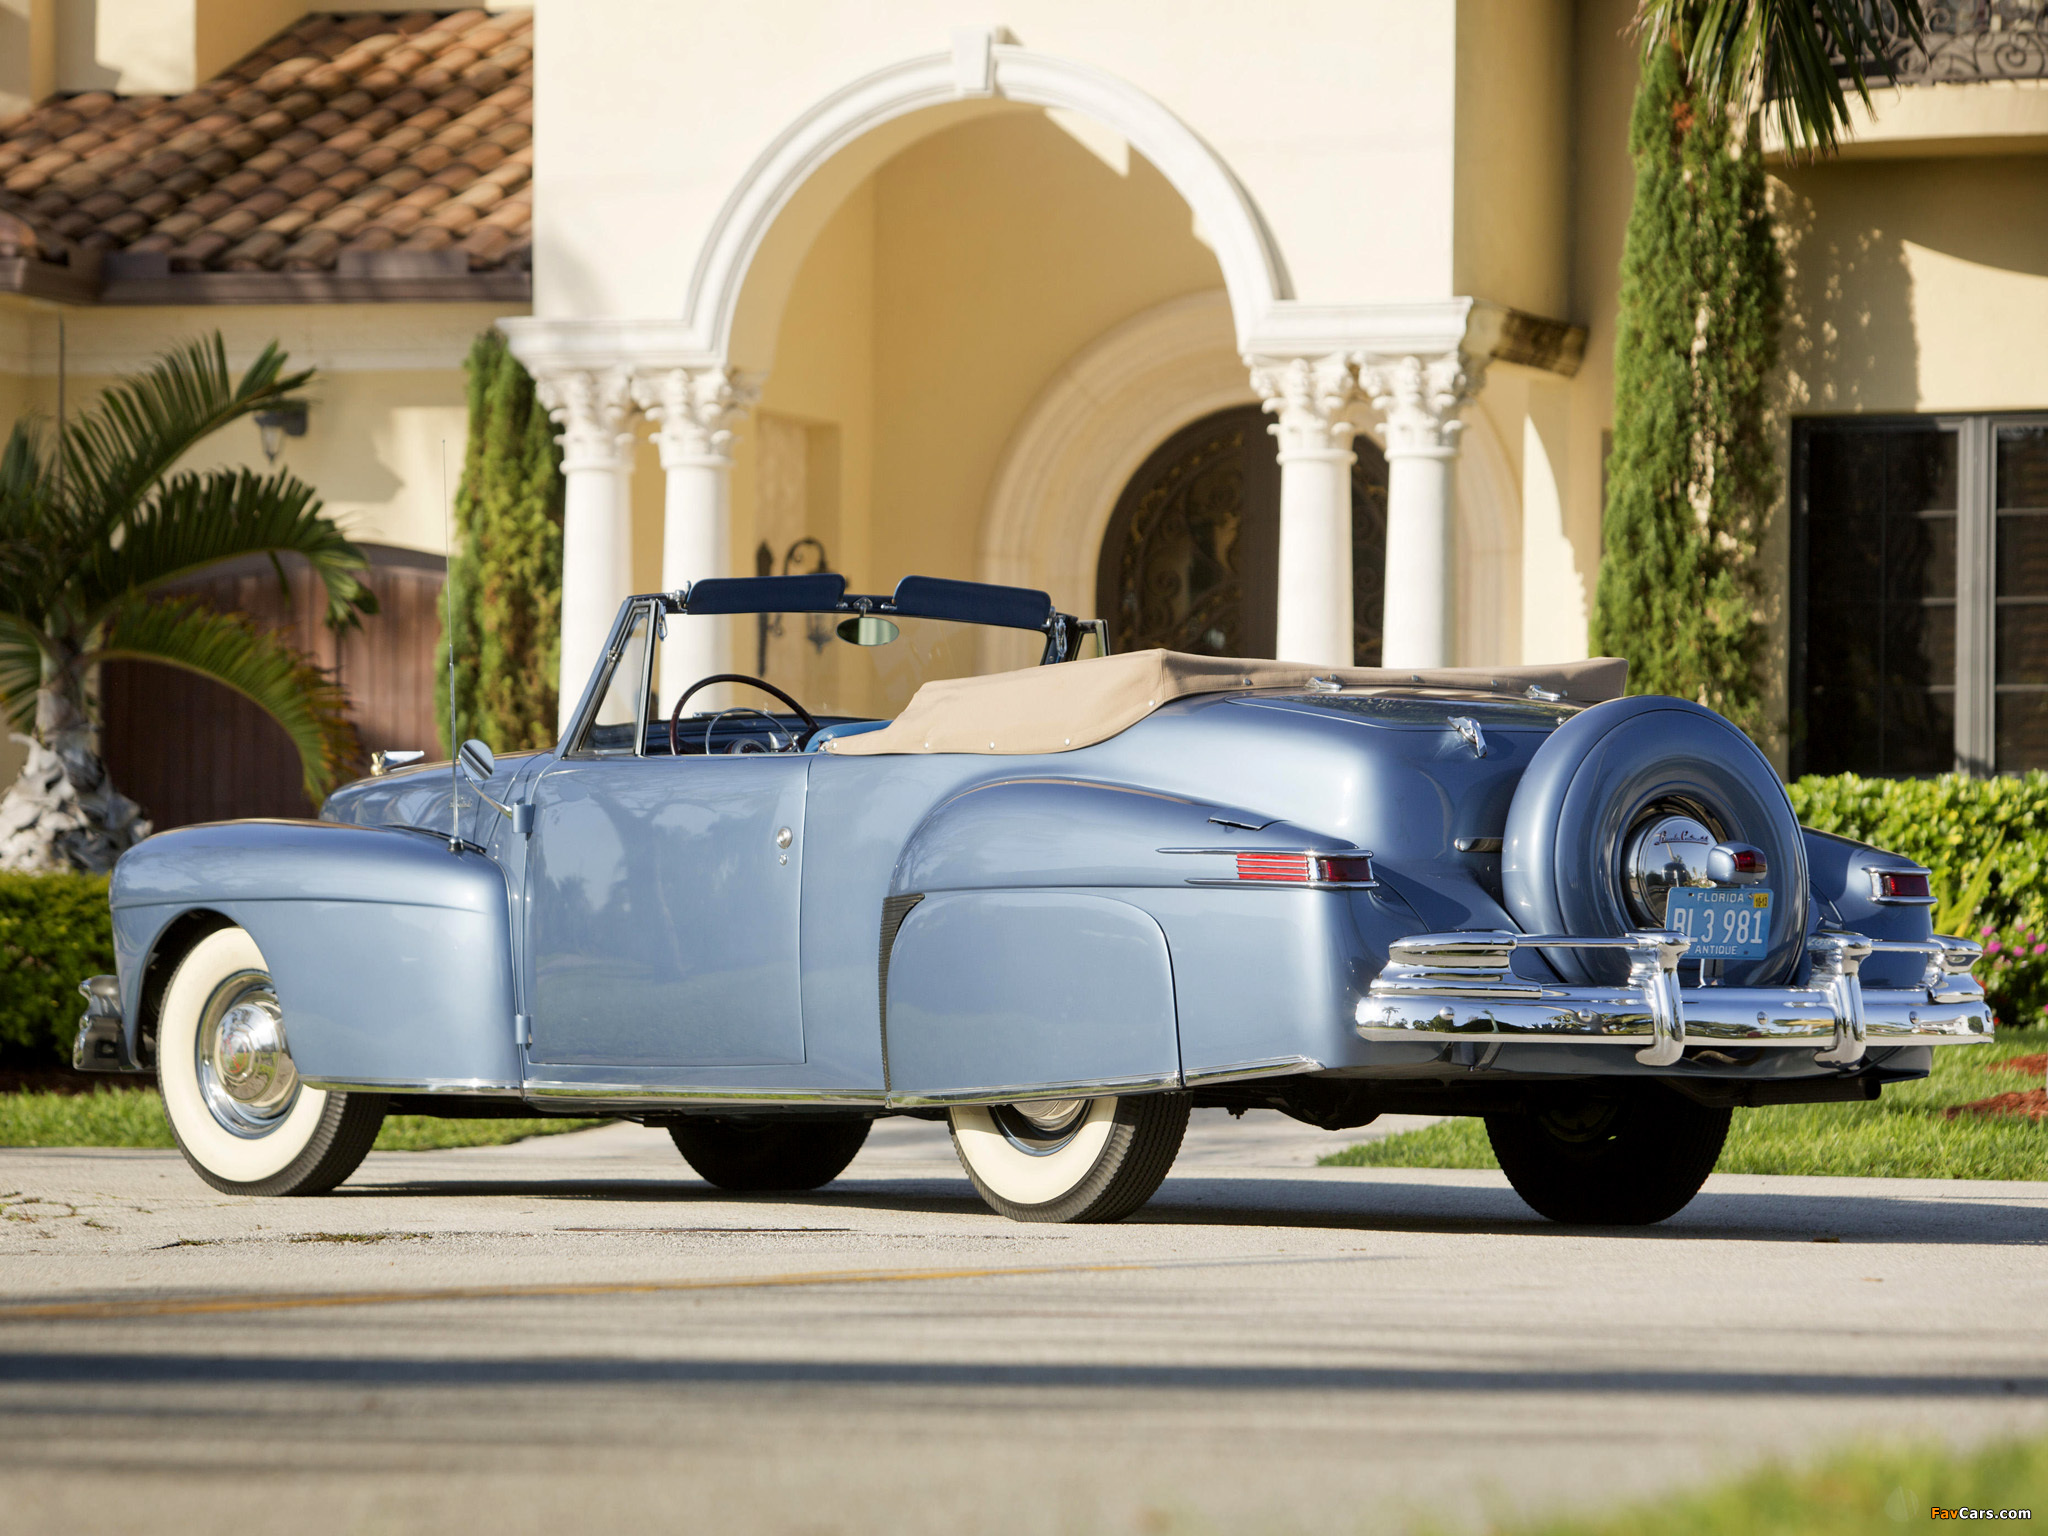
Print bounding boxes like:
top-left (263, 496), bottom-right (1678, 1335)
top-left (0, 334), bottom-right (377, 870)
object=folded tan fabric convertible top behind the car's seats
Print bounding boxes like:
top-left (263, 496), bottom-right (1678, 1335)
top-left (825, 651), bottom-right (1628, 758)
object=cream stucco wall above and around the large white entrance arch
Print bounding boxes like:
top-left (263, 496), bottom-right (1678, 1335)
top-left (535, 0), bottom-right (1456, 317)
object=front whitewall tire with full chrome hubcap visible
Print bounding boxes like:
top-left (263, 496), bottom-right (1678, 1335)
top-left (156, 928), bottom-right (385, 1194)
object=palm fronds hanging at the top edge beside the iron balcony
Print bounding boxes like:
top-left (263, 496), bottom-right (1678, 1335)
top-left (1634, 0), bottom-right (1927, 154)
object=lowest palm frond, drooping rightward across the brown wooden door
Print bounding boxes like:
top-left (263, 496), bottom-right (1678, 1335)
top-left (82, 596), bottom-right (362, 805)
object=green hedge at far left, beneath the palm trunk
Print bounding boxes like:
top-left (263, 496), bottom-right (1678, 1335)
top-left (0, 872), bottom-right (115, 1071)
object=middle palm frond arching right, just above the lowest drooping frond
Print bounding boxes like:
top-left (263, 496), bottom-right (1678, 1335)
top-left (74, 469), bottom-right (377, 629)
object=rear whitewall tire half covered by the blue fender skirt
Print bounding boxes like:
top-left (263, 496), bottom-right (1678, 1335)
top-left (948, 1094), bottom-right (1188, 1221)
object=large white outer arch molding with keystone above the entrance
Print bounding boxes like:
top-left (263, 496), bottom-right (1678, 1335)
top-left (684, 31), bottom-right (1292, 362)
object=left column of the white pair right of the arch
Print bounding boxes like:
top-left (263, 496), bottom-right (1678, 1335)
top-left (1251, 354), bottom-right (1356, 668)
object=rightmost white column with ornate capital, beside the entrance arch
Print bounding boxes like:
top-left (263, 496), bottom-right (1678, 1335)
top-left (1358, 352), bottom-right (1483, 668)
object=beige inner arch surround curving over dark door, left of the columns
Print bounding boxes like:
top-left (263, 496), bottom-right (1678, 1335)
top-left (981, 291), bottom-right (1260, 614)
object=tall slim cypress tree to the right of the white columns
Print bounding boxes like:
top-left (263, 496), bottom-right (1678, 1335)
top-left (1591, 47), bottom-right (1780, 735)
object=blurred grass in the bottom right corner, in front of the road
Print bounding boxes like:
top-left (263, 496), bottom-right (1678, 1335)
top-left (1491, 1440), bottom-right (2048, 1536)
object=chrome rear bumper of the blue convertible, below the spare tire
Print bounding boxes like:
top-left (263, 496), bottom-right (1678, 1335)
top-left (1358, 930), bottom-right (1991, 1067)
